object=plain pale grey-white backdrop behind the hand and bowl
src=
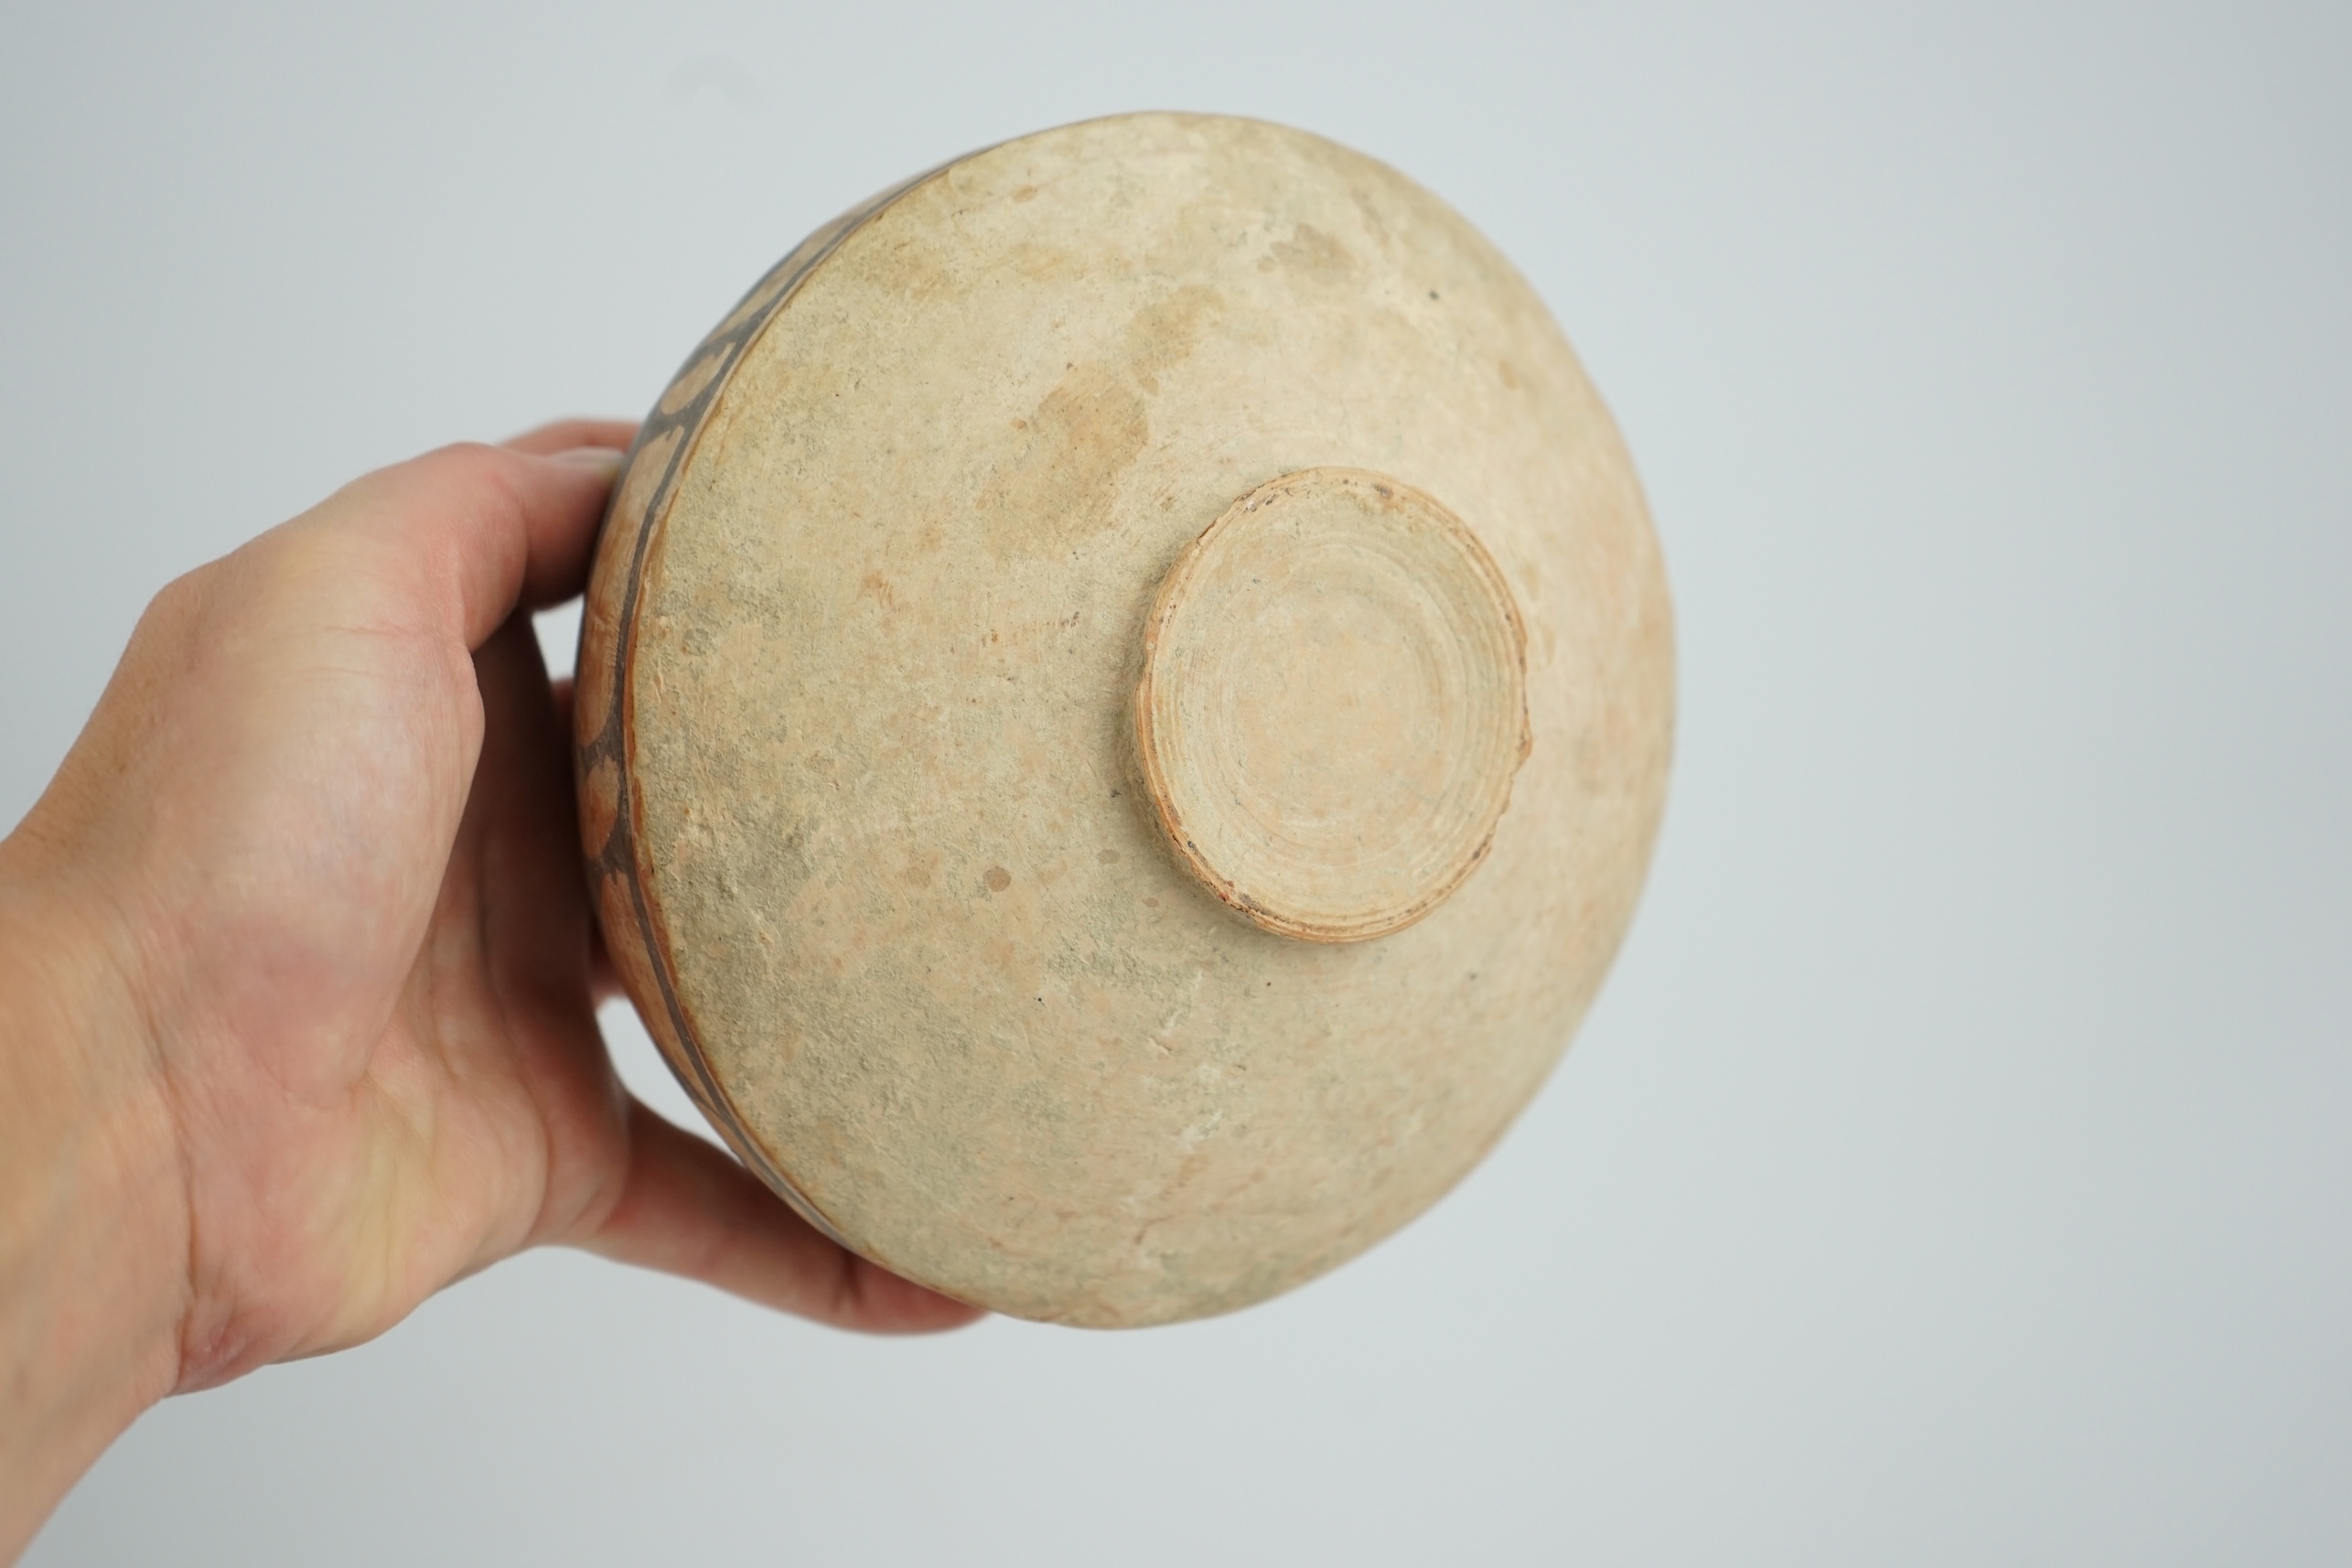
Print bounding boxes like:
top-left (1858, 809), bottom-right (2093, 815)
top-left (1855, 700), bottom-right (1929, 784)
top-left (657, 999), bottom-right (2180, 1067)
top-left (0, 0), bottom-right (2352, 1568)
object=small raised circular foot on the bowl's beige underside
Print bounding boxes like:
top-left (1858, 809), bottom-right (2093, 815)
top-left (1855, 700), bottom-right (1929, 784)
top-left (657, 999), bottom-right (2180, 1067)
top-left (1136, 467), bottom-right (1529, 942)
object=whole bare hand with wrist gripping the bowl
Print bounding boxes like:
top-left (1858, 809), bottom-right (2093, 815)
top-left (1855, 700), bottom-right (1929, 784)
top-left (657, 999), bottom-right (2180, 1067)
top-left (0, 421), bottom-right (976, 1563)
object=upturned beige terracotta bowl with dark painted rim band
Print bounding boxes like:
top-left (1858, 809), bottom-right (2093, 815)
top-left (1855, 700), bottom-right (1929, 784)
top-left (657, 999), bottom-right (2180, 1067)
top-left (576, 115), bottom-right (1672, 1326)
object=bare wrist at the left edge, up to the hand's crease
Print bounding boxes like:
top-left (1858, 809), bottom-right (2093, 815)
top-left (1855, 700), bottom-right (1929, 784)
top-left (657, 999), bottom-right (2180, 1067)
top-left (0, 834), bottom-right (188, 1563)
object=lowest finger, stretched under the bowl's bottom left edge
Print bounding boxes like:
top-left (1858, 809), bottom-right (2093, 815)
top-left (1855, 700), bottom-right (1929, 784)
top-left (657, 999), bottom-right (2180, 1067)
top-left (578, 1101), bottom-right (981, 1333)
